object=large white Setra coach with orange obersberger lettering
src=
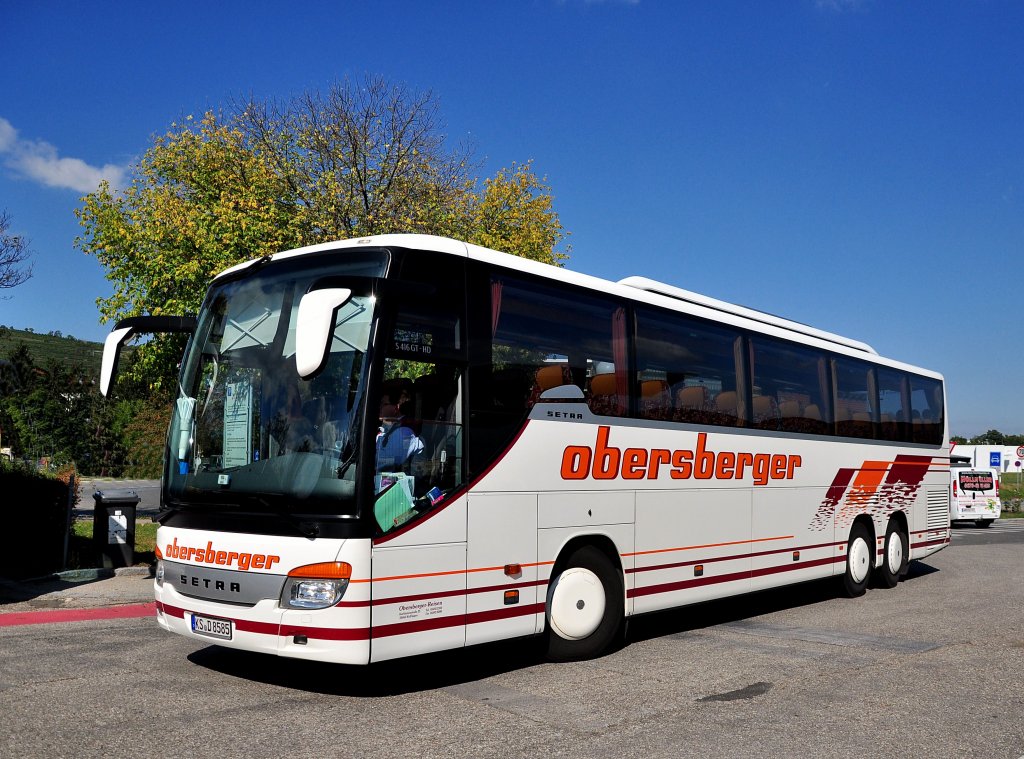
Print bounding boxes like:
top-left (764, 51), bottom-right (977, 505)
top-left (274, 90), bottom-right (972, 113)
top-left (101, 235), bottom-right (950, 664)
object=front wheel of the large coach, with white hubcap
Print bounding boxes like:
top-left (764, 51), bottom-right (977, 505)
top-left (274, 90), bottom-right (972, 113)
top-left (547, 546), bottom-right (625, 662)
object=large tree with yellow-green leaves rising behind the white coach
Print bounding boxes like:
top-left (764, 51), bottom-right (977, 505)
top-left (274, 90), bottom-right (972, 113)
top-left (76, 78), bottom-right (567, 385)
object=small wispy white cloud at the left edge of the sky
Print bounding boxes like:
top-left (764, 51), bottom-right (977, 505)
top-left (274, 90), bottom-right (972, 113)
top-left (0, 117), bottom-right (127, 193)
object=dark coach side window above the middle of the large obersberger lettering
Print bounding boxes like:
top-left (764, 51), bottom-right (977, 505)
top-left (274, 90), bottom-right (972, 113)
top-left (637, 308), bottom-right (744, 427)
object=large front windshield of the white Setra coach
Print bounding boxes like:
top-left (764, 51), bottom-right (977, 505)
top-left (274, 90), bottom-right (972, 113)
top-left (166, 251), bottom-right (387, 515)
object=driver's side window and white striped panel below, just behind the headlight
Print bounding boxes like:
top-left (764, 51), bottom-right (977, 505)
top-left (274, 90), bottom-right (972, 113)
top-left (371, 274), bottom-right (466, 662)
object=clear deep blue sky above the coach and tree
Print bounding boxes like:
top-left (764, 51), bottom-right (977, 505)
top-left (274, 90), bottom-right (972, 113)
top-left (0, 0), bottom-right (1024, 435)
